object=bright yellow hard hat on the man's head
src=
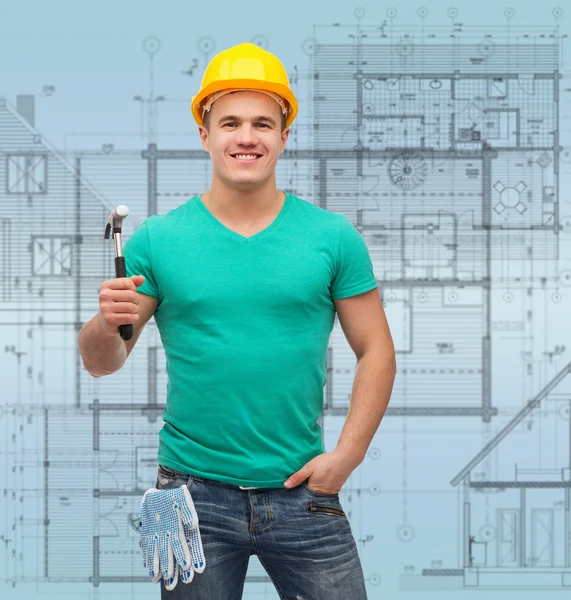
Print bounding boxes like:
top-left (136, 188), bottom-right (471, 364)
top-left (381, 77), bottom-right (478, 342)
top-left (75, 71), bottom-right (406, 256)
top-left (191, 43), bottom-right (298, 127)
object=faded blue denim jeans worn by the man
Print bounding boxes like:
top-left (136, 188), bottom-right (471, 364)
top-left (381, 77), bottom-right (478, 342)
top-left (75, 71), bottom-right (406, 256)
top-left (156, 466), bottom-right (367, 600)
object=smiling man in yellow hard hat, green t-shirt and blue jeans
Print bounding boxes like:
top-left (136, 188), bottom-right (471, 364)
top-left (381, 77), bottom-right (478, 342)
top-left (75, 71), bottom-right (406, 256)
top-left (79, 44), bottom-right (395, 600)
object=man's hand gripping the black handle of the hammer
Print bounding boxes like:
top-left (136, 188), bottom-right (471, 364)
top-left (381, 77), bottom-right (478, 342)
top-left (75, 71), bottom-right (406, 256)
top-left (99, 275), bottom-right (145, 336)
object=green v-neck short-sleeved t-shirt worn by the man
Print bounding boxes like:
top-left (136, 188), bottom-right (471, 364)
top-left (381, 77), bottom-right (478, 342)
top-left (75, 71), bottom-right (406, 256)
top-left (123, 194), bottom-right (377, 487)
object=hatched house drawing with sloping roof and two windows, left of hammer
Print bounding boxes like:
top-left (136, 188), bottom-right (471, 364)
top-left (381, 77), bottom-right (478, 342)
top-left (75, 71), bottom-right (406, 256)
top-left (0, 96), bottom-right (131, 304)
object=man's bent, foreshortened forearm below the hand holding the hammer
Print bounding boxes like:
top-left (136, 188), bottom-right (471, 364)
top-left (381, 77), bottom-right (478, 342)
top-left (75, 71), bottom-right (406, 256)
top-left (78, 315), bottom-right (127, 377)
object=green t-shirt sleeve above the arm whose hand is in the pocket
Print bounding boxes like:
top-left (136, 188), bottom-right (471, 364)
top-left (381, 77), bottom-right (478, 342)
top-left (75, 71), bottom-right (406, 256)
top-left (331, 214), bottom-right (377, 300)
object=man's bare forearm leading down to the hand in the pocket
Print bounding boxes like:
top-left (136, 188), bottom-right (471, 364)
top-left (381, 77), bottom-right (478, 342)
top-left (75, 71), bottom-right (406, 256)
top-left (335, 352), bottom-right (396, 467)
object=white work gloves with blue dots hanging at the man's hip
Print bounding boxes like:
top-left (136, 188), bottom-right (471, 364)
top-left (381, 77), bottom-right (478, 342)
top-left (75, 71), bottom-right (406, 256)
top-left (139, 485), bottom-right (206, 590)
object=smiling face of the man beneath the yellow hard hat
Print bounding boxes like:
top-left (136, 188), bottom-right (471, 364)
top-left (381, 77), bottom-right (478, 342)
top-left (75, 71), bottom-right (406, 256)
top-left (199, 91), bottom-right (289, 190)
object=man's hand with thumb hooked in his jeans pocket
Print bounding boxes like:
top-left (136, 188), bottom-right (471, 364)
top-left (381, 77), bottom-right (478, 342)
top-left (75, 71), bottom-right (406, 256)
top-left (285, 449), bottom-right (357, 494)
